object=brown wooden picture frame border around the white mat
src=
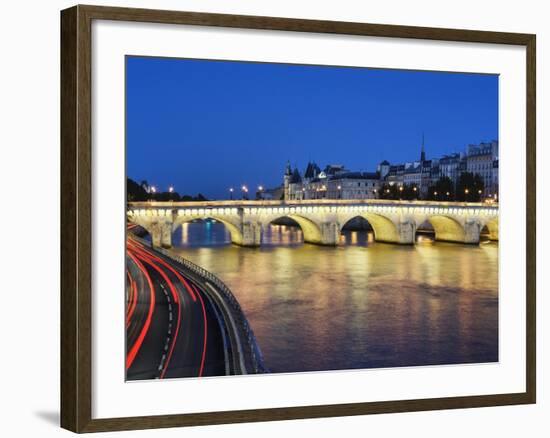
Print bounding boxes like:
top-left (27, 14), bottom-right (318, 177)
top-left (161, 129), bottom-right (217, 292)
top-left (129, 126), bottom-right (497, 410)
top-left (61, 6), bottom-right (536, 432)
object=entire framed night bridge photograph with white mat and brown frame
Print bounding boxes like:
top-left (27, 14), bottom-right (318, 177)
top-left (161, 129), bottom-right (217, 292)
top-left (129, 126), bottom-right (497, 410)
top-left (61, 6), bottom-right (536, 432)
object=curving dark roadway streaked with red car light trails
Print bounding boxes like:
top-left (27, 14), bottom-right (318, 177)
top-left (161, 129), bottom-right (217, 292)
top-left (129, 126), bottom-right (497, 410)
top-left (126, 227), bottom-right (228, 380)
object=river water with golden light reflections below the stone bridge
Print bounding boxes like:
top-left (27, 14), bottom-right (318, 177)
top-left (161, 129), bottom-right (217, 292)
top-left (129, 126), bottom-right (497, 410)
top-left (175, 224), bottom-right (498, 372)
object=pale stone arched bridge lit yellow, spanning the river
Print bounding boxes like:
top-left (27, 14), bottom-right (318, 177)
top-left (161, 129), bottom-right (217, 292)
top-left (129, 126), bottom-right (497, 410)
top-left (127, 199), bottom-right (498, 247)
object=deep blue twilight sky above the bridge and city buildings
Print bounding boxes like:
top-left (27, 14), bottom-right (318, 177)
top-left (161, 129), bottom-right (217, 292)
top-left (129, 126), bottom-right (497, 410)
top-left (126, 57), bottom-right (498, 198)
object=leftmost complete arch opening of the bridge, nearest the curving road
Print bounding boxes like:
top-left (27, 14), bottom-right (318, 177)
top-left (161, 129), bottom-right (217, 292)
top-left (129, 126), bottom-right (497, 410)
top-left (172, 217), bottom-right (243, 247)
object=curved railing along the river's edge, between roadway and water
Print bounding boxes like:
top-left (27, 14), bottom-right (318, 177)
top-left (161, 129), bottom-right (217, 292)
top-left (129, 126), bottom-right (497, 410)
top-left (133, 237), bottom-right (267, 373)
